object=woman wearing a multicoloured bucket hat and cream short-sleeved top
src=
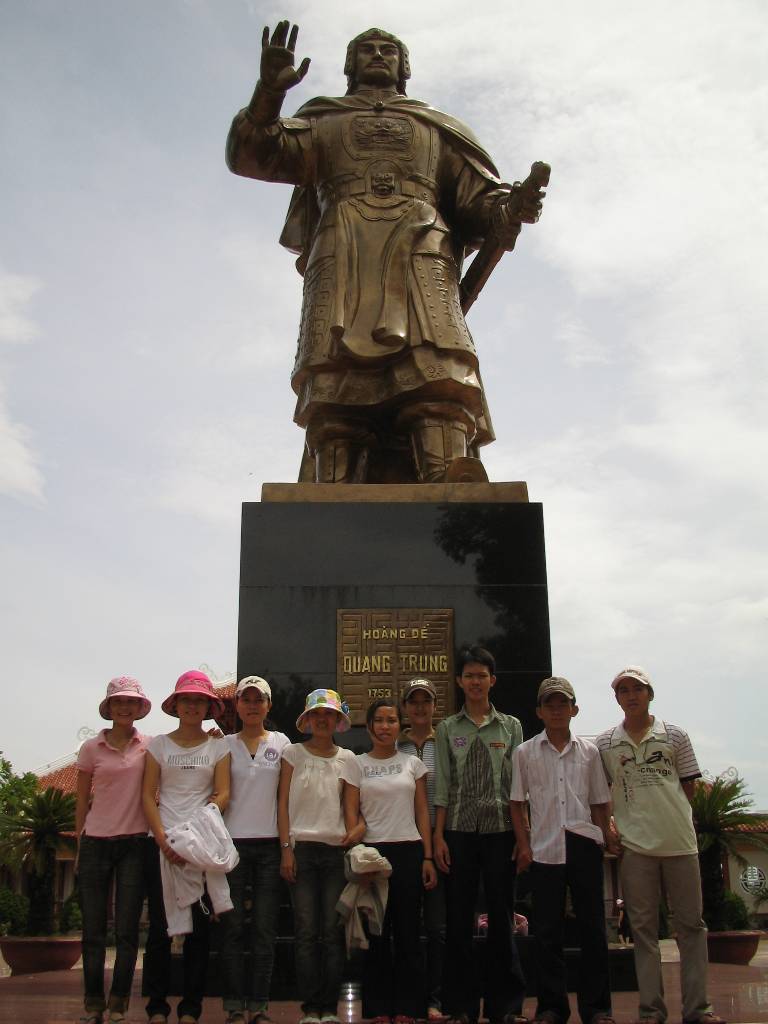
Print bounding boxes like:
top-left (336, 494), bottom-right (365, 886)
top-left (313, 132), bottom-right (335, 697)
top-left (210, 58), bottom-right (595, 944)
top-left (278, 689), bottom-right (365, 1024)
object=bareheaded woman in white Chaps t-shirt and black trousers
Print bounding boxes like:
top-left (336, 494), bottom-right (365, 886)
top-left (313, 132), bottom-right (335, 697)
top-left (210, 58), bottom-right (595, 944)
top-left (355, 697), bottom-right (437, 1024)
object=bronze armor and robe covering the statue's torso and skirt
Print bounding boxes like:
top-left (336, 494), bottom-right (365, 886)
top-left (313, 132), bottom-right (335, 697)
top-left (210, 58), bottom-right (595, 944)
top-left (288, 108), bottom-right (487, 443)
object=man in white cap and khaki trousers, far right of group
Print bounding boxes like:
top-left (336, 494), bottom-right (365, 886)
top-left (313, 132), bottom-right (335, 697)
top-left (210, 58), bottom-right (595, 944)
top-left (597, 666), bottom-right (723, 1024)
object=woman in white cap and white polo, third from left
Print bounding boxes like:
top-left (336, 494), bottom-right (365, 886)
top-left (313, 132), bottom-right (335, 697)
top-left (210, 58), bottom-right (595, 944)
top-left (220, 676), bottom-right (291, 1024)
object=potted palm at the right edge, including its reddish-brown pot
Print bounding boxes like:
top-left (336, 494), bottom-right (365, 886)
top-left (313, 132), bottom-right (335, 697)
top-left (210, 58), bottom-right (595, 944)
top-left (691, 768), bottom-right (768, 964)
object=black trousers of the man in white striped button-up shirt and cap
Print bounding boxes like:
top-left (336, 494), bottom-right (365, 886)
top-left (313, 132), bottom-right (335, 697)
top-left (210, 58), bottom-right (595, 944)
top-left (530, 831), bottom-right (610, 1024)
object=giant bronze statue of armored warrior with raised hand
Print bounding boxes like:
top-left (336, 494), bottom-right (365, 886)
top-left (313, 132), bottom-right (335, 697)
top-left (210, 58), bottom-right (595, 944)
top-left (226, 22), bottom-right (549, 483)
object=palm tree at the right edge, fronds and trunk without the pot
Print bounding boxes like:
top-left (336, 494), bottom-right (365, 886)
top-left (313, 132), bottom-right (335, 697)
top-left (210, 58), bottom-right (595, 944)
top-left (691, 768), bottom-right (768, 932)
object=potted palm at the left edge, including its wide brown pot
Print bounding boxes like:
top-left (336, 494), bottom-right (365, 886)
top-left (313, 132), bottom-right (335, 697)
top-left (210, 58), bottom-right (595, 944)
top-left (0, 788), bottom-right (81, 974)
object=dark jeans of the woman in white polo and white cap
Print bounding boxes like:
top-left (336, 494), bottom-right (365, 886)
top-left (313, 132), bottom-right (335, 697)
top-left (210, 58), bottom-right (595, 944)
top-left (219, 839), bottom-right (281, 1013)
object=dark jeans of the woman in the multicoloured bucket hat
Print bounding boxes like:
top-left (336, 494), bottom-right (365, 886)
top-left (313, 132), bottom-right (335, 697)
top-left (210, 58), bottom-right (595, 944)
top-left (290, 843), bottom-right (346, 1016)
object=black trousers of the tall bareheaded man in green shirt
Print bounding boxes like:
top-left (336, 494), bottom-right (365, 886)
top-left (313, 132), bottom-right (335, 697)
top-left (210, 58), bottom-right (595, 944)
top-left (442, 831), bottom-right (525, 1024)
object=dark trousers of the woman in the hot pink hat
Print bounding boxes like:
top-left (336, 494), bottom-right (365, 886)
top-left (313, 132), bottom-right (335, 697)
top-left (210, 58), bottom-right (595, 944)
top-left (143, 840), bottom-right (210, 1020)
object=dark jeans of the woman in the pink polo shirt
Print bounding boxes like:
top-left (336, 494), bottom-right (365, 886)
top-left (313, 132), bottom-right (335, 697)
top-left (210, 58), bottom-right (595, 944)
top-left (78, 836), bottom-right (148, 1014)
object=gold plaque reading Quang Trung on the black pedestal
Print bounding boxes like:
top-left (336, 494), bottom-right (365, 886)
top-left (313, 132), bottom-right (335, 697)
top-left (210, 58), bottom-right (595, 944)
top-left (336, 608), bottom-right (455, 725)
